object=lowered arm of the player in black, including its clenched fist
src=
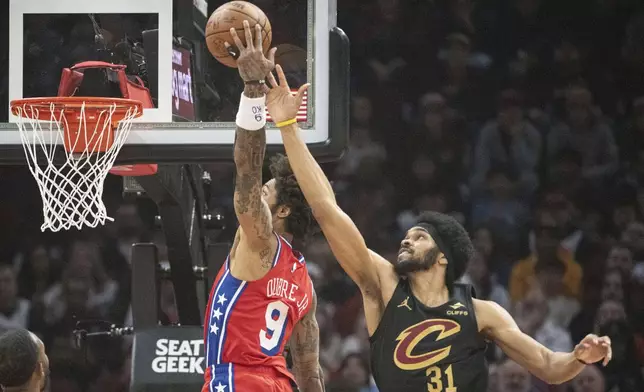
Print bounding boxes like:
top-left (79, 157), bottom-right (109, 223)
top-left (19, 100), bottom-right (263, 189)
top-left (474, 299), bottom-right (612, 384)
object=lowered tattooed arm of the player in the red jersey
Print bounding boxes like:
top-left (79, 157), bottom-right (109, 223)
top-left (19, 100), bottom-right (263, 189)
top-left (290, 290), bottom-right (324, 392)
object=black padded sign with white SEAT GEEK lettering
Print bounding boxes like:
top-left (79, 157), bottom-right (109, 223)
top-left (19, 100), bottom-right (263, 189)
top-left (131, 327), bottom-right (205, 392)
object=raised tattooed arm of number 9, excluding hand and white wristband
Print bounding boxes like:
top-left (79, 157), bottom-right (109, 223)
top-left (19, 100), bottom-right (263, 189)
top-left (234, 85), bottom-right (275, 249)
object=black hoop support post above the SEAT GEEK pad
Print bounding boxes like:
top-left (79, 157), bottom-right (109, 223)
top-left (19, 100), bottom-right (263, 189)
top-left (136, 165), bottom-right (206, 326)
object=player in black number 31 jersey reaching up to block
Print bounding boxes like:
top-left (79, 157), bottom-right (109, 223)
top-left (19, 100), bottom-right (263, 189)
top-left (267, 65), bottom-right (612, 392)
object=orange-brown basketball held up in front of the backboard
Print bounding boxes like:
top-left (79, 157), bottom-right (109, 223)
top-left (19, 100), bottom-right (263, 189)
top-left (206, 1), bottom-right (273, 68)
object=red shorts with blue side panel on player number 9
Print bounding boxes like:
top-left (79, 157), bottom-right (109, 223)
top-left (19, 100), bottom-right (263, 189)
top-left (201, 364), bottom-right (293, 392)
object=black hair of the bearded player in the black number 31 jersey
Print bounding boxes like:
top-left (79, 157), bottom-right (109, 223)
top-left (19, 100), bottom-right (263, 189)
top-left (418, 211), bottom-right (474, 292)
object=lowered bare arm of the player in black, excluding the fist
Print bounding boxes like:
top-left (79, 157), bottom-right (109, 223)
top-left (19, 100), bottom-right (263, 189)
top-left (473, 299), bottom-right (584, 384)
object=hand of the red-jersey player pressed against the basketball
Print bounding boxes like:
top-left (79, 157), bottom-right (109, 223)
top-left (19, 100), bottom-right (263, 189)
top-left (224, 20), bottom-right (277, 82)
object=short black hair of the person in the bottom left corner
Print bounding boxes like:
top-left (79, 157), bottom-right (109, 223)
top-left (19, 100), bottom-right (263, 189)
top-left (0, 329), bottom-right (38, 387)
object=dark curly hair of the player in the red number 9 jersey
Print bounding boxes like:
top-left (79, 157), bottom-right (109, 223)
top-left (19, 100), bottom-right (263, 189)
top-left (269, 154), bottom-right (315, 241)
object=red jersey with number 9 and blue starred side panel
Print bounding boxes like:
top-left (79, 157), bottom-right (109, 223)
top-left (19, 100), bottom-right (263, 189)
top-left (203, 234), bottom-right (313, 392)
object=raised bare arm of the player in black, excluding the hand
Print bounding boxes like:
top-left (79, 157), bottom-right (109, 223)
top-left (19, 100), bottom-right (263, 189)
top-left (280, 124), bottom-right (381, 300)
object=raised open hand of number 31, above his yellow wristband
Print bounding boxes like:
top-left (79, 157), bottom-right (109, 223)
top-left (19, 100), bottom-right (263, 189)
top-left (266, 64), bottom-right (311, 124)
